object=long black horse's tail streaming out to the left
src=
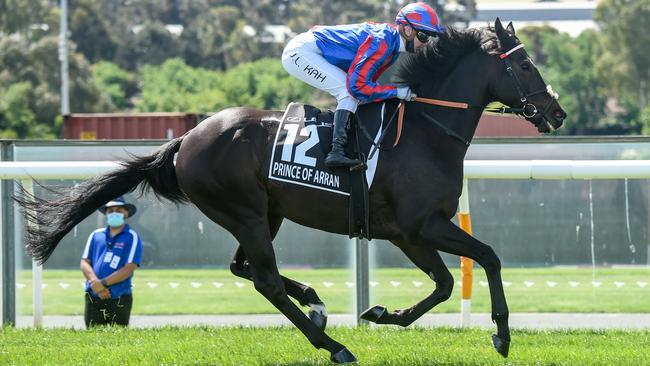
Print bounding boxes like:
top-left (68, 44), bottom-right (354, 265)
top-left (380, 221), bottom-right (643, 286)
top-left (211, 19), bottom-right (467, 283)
top-left (14, 136), bottom-right (188, 263)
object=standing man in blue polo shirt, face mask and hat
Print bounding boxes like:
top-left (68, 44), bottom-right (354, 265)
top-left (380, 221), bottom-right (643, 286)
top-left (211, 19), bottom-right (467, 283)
top-left (80, 197), bottom-right (142, 328)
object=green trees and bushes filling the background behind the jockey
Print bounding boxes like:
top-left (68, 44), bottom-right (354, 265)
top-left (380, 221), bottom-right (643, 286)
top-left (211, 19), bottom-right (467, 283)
top-left (0, 0), bottom-right (650, 137)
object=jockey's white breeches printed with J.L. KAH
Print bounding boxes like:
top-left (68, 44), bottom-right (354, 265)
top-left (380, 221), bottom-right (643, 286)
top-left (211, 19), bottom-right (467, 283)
top-left (282, 32), bottom-right (359, 113)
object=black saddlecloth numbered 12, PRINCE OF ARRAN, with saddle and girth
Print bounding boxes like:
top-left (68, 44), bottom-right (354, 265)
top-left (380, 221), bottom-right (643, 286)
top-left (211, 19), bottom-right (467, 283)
top-left (269, 103), bottom-right (396, 240)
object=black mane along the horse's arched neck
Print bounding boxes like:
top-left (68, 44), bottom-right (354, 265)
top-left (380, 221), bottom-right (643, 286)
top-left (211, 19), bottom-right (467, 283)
top-left (393, 27), bottom-right (500, 91)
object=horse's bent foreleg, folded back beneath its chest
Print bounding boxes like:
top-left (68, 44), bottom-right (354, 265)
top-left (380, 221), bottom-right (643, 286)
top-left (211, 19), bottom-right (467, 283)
top-left (361, 241), bottom-right (454, 327)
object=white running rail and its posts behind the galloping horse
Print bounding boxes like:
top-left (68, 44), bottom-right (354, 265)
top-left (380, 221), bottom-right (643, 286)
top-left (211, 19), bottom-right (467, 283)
top-left (5, 160), bottom-right (650, 326)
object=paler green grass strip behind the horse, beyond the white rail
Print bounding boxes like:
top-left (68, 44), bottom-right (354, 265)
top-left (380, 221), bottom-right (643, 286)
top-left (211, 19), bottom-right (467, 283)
top-left (12, 268), bottom-right (650, 315)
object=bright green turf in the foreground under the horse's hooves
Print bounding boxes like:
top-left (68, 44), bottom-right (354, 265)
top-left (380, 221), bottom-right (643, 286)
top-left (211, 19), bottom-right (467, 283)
top-left (0, 327), bottom-right (650, 366)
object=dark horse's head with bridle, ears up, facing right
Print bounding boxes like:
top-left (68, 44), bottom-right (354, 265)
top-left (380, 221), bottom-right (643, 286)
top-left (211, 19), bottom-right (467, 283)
top-left (491, 18), bottom-right (566, 132)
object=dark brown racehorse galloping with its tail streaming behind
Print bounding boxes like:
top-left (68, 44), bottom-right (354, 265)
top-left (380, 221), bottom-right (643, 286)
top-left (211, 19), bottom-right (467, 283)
top-left (17, 19), bottom-right (566, 363)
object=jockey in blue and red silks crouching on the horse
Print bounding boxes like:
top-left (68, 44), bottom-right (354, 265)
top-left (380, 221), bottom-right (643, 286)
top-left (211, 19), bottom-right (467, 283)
top-left (282, 2), bottom-right (444, 167)
